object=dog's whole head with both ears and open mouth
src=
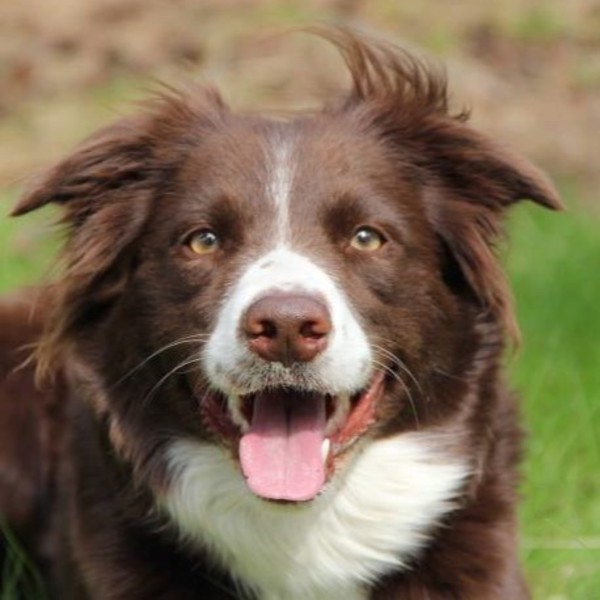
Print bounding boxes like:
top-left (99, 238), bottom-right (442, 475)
top-left (15, 31), bottom-right (559, 501)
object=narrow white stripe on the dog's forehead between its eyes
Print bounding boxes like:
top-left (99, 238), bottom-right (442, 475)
top-left (267, 135), bottom-right (294, 244)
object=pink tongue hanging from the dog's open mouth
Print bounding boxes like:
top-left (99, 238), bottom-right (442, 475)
top-left (240, 391), bottom-right (325, 502)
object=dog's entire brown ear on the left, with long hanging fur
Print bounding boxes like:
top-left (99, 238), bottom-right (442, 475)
top-left (12, 89), bottom-right (225, 373)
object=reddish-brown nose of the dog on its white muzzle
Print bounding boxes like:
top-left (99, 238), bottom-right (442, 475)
top-left (242, 293), bottom-right (331, 365)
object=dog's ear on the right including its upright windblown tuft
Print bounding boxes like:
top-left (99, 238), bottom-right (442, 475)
top-left (314, 28), bottom-right (561, 338)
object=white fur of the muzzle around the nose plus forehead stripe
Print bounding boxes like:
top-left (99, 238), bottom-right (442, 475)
top-left (202, 131), bottom-right (373, 420)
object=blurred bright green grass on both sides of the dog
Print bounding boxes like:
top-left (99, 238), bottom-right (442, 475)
top-left (0, 190), bottom-right (600, 600)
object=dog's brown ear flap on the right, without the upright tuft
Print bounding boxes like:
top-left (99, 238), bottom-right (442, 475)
top-left (421, 118), bottom-right (562, 338)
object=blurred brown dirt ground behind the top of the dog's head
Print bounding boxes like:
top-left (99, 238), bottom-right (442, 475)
top-left (0, 0), bottom-right (600, 208)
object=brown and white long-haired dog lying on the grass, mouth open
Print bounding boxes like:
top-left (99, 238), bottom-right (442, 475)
top-left (0, 29), bottom-right (561, 600)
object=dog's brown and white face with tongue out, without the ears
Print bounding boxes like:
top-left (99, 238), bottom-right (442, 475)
top-left (118, 116), bottom-right (462, 501)
